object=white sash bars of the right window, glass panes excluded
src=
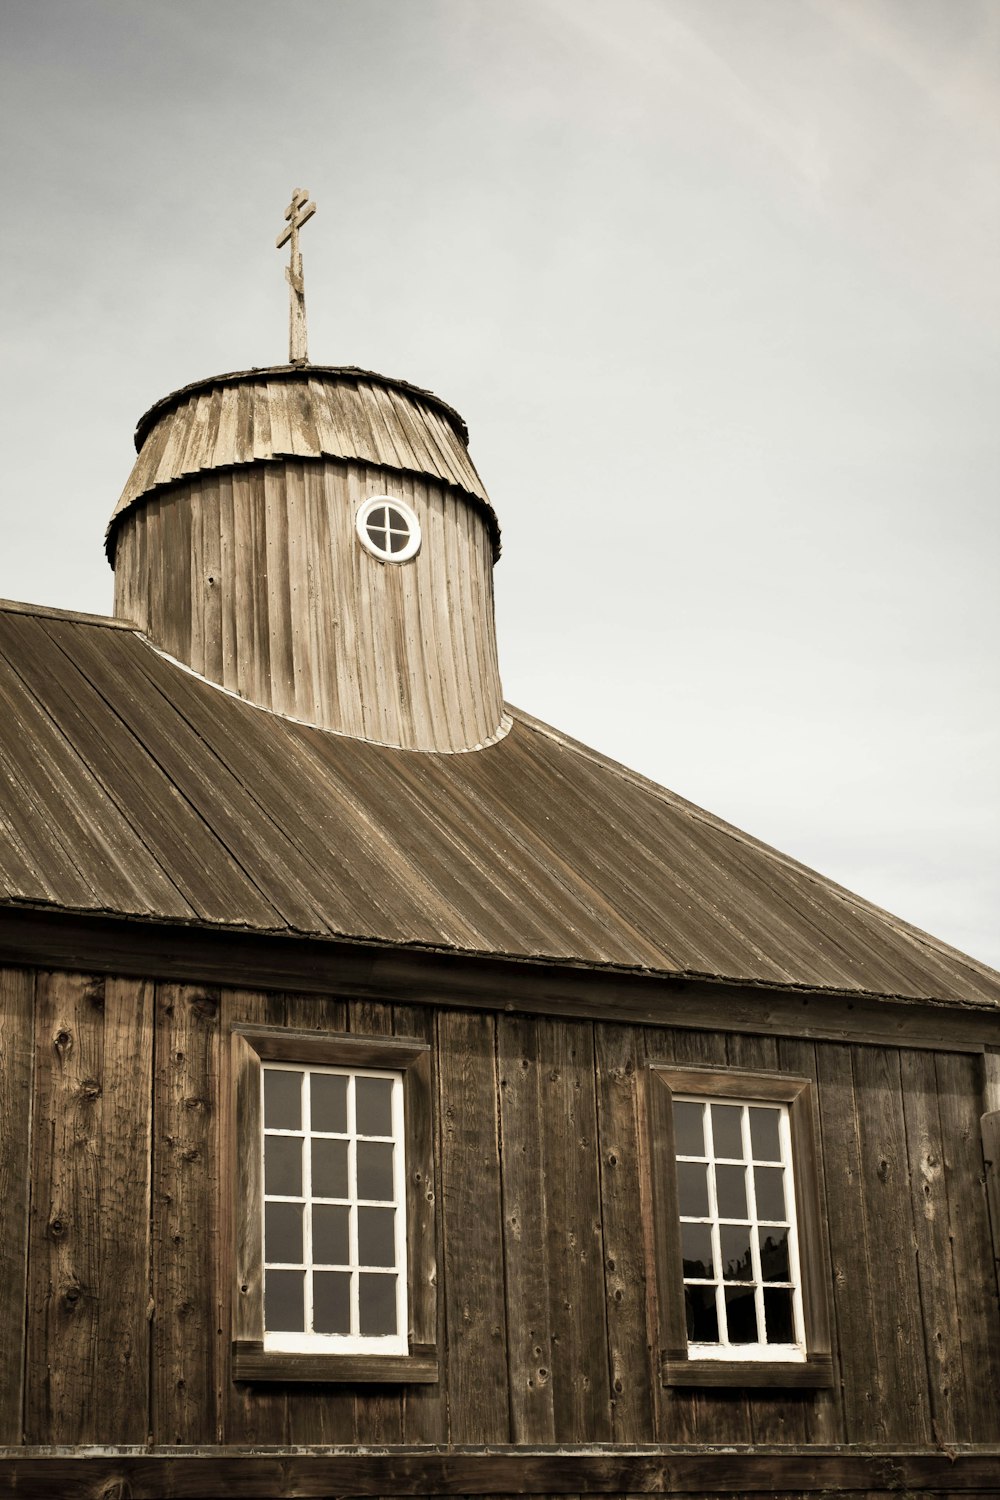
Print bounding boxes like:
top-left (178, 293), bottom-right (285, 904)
top-left (673, 1094), bottom-right (805, 1362)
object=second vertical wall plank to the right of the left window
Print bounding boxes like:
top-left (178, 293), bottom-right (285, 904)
top-left (496, 1016), bottom-right (558, 1443)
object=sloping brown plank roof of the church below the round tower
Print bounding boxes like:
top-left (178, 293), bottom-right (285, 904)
top-left (0, 605), bottom-right (1000, 1005)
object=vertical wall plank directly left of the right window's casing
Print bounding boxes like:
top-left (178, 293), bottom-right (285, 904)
top-left (594, 1025), bottom-right (658, 1443)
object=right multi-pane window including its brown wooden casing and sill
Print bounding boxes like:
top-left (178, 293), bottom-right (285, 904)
top-left (645, 1062), bottom-right (834, 1389)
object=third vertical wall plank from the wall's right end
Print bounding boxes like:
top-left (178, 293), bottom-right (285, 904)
top-left (853, 1047), bottom-right (931, 1443)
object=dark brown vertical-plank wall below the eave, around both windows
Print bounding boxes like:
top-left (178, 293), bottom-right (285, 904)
top-left (0, 969), bottom-right (1000, 1445)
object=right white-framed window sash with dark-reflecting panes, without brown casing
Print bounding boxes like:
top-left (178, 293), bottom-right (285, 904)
top-left (673, 1095), bottom-right (805, 1361)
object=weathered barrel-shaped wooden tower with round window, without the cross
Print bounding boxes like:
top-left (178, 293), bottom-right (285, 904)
top-left (106, 365), bottom-right (507, 752)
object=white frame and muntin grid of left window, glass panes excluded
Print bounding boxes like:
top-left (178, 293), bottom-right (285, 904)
top-left (261, 1062), bottom-right (408, 1355)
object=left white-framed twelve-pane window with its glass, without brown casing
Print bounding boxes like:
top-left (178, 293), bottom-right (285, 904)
top-left (261, 1062), bottom-right (406, 1355)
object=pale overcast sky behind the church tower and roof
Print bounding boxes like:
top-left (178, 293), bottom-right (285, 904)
top-left (0, 0), bottom-right (1000, 965)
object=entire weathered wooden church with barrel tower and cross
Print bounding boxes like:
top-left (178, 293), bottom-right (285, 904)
top-left (0, 192), bottom-right (1000, 1500)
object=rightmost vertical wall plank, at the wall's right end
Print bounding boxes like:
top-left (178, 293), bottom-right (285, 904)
top-left (934, 1053), bottom-right (1000, 1443)
